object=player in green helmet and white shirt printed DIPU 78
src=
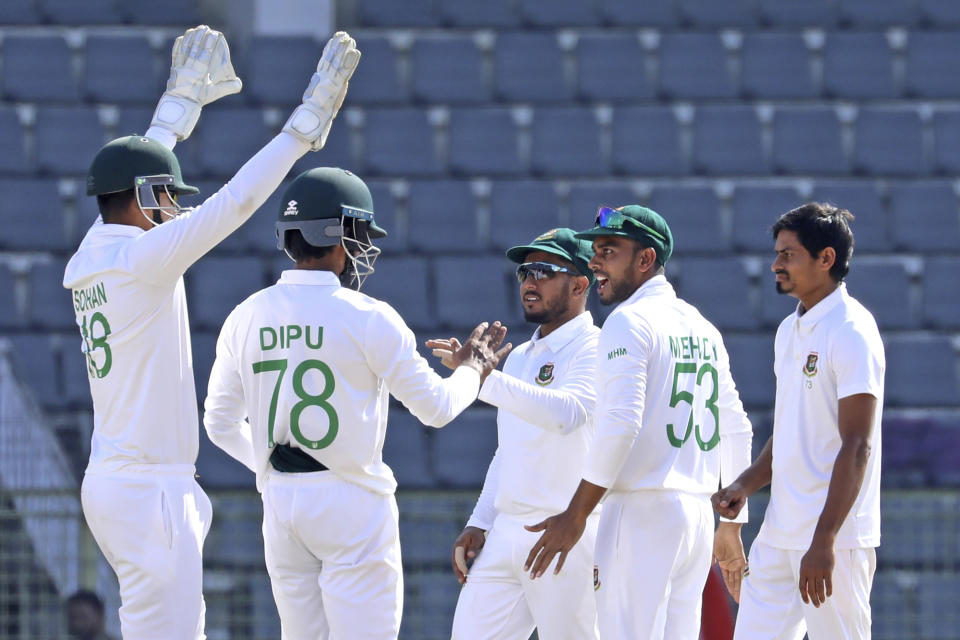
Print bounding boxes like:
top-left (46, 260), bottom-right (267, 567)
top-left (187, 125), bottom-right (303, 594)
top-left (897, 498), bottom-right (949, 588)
top-left (203, 167), bottom-right (510, 640)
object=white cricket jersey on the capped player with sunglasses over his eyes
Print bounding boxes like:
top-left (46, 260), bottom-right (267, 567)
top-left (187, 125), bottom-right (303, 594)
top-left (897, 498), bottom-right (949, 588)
top-left (467, 311), bottom-right (600, 530)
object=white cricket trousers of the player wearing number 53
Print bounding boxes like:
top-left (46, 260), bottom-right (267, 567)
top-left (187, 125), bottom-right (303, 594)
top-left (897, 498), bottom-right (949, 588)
top-left (597, 490), bottom-right (713, 640)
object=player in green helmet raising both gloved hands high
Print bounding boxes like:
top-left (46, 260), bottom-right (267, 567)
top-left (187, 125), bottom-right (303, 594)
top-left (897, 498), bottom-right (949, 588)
top-left (63, 25), bottom-right (360, 639)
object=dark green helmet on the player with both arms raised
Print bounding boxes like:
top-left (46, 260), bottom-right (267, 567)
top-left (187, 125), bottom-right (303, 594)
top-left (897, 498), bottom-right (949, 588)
top-left (87, 135), bottom-right (200, 196)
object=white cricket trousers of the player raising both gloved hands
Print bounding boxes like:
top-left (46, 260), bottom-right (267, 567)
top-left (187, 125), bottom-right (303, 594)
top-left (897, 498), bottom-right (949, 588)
top-left (80, 464), bottom-right (212, 640)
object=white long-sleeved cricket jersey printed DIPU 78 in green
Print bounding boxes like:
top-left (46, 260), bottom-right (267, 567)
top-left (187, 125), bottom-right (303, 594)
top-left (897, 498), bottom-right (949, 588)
top-left (203, 269), bottom-right (480, 494)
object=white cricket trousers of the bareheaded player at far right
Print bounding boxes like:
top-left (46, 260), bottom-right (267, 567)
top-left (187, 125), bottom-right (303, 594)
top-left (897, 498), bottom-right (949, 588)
top-left (733, 540), bottom-right (877, 640)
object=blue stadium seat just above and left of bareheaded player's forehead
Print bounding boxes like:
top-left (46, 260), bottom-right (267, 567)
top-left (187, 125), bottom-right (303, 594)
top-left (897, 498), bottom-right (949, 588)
top-left (732, 184), bottom-right (803, 251)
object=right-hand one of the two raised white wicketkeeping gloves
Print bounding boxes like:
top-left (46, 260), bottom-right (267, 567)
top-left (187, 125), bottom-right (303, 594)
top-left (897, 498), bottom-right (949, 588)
top-left (283, 31), bottom-right (360, 151)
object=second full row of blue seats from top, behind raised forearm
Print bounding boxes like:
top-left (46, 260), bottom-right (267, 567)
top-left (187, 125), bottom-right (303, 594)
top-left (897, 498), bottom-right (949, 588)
top-left (7, 105), bottom-right (960, 180)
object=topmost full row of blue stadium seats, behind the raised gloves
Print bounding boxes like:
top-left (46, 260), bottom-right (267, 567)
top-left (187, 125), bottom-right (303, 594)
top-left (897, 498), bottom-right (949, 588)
top-left (0, 30), bottom-right (960, 105)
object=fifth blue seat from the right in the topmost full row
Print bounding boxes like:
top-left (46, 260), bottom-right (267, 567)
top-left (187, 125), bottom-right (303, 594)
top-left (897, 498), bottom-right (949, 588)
top-left (577, 33), bottom-right (654, 102)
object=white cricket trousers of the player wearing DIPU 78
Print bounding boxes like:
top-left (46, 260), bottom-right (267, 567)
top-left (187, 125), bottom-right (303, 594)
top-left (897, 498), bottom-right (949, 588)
top-left (263, 470), bottom-right (403, 640)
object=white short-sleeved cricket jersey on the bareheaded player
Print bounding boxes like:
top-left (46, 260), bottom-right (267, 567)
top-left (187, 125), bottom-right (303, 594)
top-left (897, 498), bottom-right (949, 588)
top-left (758, 283), bottom-right (886, 550)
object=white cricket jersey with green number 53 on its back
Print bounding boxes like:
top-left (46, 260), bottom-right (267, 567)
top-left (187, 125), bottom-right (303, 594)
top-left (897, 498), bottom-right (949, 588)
top-left (583, 275), bottom-right (753, 522)
